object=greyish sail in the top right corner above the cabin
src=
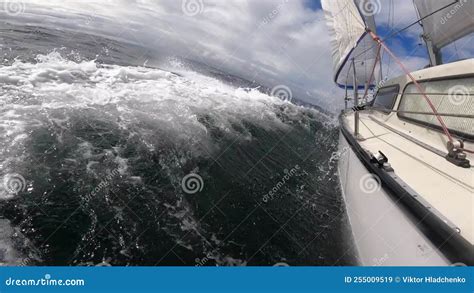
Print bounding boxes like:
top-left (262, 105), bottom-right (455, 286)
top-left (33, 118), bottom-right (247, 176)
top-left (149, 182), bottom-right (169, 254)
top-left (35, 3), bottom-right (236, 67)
top-left (415, 0), bottom-right (474, 49)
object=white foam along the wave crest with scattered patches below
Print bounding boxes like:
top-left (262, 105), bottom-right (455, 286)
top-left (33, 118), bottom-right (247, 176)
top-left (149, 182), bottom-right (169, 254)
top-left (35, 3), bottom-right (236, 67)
top-left (0, 52), bottom-right (330, 265)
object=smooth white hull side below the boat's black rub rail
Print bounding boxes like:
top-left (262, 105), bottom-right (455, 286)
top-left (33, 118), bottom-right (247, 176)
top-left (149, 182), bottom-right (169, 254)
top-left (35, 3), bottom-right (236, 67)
top-left (338, 133), bottom-right (451, 266)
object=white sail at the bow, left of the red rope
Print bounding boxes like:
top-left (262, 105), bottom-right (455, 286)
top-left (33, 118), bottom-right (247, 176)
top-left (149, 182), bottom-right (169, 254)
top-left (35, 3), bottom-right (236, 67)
top-left (321, 0), bottom-right (377, 88)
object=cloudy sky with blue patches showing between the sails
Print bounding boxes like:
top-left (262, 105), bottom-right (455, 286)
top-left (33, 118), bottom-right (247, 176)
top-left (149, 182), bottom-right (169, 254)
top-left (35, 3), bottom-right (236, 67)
top-left (0, 0), bottom-right (472, 107)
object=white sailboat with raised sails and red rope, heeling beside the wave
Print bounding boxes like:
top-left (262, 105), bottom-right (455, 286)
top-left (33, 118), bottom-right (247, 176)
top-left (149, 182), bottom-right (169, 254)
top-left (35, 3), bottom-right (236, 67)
top-left (321, 0), bottom-right (474, 266)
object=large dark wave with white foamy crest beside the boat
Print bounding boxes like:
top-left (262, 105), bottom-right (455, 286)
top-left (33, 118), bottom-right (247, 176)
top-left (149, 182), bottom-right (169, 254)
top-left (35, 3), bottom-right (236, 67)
top-left (0, 51), bottom-right (343, 265)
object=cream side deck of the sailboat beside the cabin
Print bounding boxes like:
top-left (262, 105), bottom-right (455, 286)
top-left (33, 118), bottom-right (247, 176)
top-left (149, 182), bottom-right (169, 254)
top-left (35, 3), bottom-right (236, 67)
top-left (343, 111), bottom-right (474, 244)
